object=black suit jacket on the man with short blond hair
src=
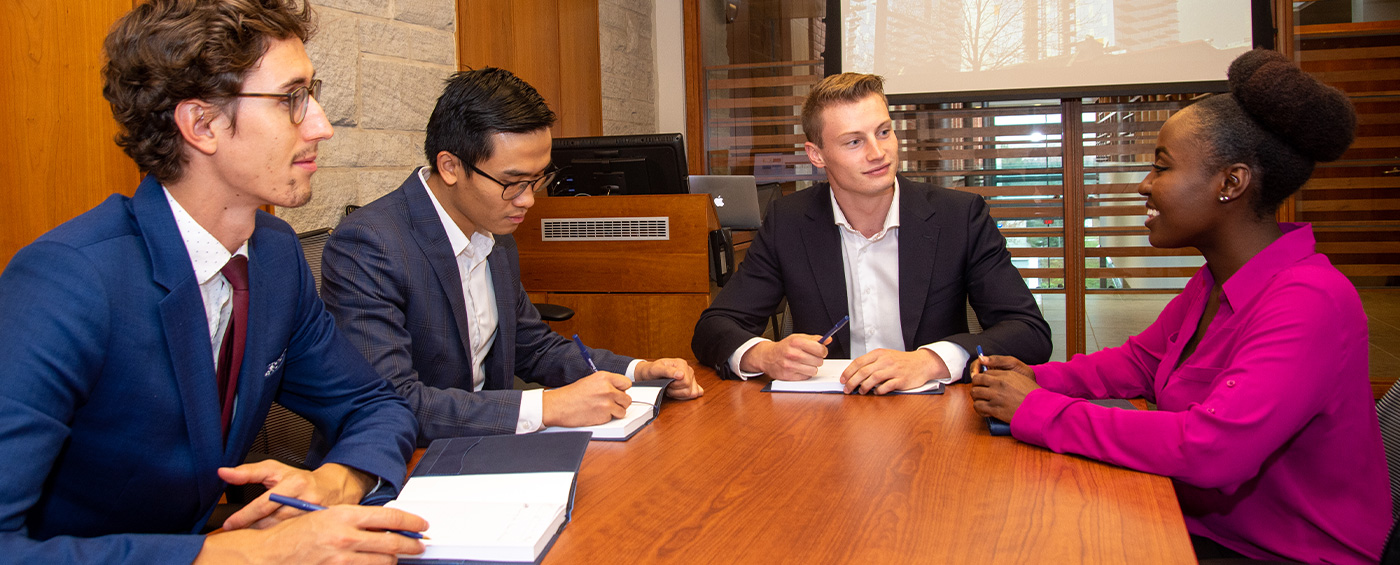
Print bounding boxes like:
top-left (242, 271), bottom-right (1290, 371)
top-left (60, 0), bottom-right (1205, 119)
top-left (690, 178), bottom-right (1050, 378)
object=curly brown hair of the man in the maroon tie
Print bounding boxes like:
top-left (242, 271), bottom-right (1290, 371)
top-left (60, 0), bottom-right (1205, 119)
top-left (102, 0), bottom-right (314, 182)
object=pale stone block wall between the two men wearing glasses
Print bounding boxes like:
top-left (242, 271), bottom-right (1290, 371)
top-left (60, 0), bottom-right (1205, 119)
top-left (277, 0), bottom-right (456, 231)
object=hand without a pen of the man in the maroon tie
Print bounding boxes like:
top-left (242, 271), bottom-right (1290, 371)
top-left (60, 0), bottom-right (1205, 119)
top-left (218, 459), bottom-right (375, 530)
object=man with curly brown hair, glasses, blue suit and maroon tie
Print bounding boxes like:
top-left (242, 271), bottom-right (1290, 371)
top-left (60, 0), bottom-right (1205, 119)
top-left (0, 0), bottom-right (427, 564)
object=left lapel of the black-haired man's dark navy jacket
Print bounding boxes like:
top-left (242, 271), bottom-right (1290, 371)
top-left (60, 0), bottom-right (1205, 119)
top-left (402, 171), bottom-right (472, 376)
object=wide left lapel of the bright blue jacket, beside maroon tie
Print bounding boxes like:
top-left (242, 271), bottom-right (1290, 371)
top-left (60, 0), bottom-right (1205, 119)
top-left (132, 176), bottom-right (224, 499)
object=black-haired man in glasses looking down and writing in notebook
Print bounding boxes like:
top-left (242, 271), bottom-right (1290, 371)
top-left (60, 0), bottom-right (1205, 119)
top-left (322, 69), bottom-right (703, 445)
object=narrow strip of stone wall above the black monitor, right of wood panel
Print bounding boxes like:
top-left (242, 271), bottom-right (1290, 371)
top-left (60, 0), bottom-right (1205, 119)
top-left (598, 0), bottom-right (658, 136)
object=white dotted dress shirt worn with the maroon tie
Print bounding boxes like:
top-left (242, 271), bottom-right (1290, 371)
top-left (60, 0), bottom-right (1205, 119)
top-left (161, 186), bottom-right (248, 427)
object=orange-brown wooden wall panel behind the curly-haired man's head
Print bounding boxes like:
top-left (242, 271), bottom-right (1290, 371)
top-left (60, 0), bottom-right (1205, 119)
top-left (0, 0), bottom-right (140, 270)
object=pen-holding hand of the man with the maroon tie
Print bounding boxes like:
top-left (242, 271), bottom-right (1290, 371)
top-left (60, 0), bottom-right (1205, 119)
top-left (195, 505), bottom-right (428, 564)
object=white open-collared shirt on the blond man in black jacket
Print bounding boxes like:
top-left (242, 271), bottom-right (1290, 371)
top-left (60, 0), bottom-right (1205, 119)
top-left (729, 180), bottom-right (970, 386)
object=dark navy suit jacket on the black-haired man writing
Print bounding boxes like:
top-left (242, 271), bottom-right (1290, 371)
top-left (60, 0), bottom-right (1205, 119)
top-left (321, 171), bottom-right (631, 445)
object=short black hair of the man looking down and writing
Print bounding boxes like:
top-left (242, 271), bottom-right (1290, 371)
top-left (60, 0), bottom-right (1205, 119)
top-left (423, 67), bottom-right (554, 172)
